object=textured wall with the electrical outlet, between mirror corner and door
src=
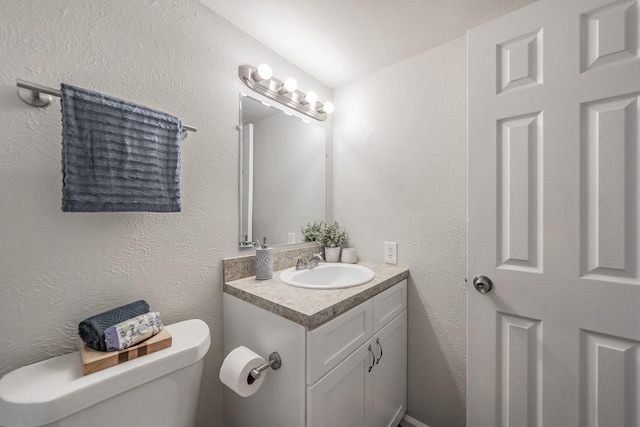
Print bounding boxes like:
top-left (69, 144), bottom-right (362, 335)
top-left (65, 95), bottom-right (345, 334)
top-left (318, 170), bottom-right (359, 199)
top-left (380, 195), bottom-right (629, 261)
top-left (334, 38), bottom-right (467, 427)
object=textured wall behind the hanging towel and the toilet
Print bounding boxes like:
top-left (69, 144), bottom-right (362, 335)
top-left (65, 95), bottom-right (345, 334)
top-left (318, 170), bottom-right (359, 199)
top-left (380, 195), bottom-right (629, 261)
top-left (0, 0), bottom-right (332, 427)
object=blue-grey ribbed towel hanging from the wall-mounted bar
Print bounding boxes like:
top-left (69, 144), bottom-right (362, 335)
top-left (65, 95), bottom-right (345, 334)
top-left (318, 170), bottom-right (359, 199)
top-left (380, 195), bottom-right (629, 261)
top-left (61, 84), bottom-right (182, 212)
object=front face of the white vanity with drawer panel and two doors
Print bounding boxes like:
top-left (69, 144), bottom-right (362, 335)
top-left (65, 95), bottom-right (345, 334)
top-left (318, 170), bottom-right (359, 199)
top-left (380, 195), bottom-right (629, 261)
top-left (307, 280), bottom-right (407, 427)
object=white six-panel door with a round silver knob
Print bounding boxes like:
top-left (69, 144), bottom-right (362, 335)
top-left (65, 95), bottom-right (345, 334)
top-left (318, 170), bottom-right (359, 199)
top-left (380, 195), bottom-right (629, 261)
top-left (467, 0), bottom-right (640, 427)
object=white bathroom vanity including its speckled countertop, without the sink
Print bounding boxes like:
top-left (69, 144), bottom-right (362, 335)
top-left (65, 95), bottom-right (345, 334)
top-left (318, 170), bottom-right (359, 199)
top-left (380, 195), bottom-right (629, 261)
top-left (223, 262), bottom-right (408, 427)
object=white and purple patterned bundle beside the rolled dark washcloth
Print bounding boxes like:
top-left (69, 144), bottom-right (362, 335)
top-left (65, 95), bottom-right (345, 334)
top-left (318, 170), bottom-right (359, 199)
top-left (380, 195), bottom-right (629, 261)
top-left (104, 311), bottom-right (162, 351)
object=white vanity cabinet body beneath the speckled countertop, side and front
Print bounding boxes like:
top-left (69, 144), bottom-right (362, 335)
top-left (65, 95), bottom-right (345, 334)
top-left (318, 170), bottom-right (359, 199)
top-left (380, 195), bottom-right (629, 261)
top-left (223, 279), bottom-right (407, 427)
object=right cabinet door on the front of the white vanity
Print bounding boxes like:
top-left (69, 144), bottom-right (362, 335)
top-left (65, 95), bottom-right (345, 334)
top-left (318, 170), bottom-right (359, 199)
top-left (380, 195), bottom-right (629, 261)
top-left (370, 310), bottom-right (407, 427)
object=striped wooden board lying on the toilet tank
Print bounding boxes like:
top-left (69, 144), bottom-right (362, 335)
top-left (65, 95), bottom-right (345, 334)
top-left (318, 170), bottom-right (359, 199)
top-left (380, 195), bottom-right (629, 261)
top-left (80, 328), bottom-right (171, 375)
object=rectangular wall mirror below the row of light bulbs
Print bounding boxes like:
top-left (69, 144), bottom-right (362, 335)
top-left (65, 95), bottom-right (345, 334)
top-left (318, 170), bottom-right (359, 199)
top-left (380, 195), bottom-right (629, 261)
top-left (240, 96), bottom-right (326, 248)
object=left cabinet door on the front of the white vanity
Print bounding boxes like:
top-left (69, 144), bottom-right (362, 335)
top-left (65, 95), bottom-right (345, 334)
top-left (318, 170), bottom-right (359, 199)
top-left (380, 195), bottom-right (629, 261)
top-left (307, 341), bottom-right (375, 427)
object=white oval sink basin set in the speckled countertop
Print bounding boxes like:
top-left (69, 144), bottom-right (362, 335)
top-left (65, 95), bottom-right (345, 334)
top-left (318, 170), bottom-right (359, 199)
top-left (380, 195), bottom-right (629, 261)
top-left (280, 263), bottom-right (376, 289)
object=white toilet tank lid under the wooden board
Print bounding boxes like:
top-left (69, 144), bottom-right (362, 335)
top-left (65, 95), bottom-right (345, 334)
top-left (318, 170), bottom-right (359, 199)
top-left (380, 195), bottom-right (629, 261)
top-left (0, 319), bottom-right (211, 427)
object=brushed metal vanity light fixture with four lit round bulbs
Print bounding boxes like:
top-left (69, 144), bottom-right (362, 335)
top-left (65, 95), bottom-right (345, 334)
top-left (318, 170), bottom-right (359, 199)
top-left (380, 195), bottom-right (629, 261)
top-left (238, 64), bottom-right (334, 121)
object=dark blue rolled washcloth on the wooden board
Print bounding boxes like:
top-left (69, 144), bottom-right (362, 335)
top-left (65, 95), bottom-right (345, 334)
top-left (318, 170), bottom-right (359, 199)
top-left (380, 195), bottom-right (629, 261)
top-left (78, 300), bottom-right (149, 351)
